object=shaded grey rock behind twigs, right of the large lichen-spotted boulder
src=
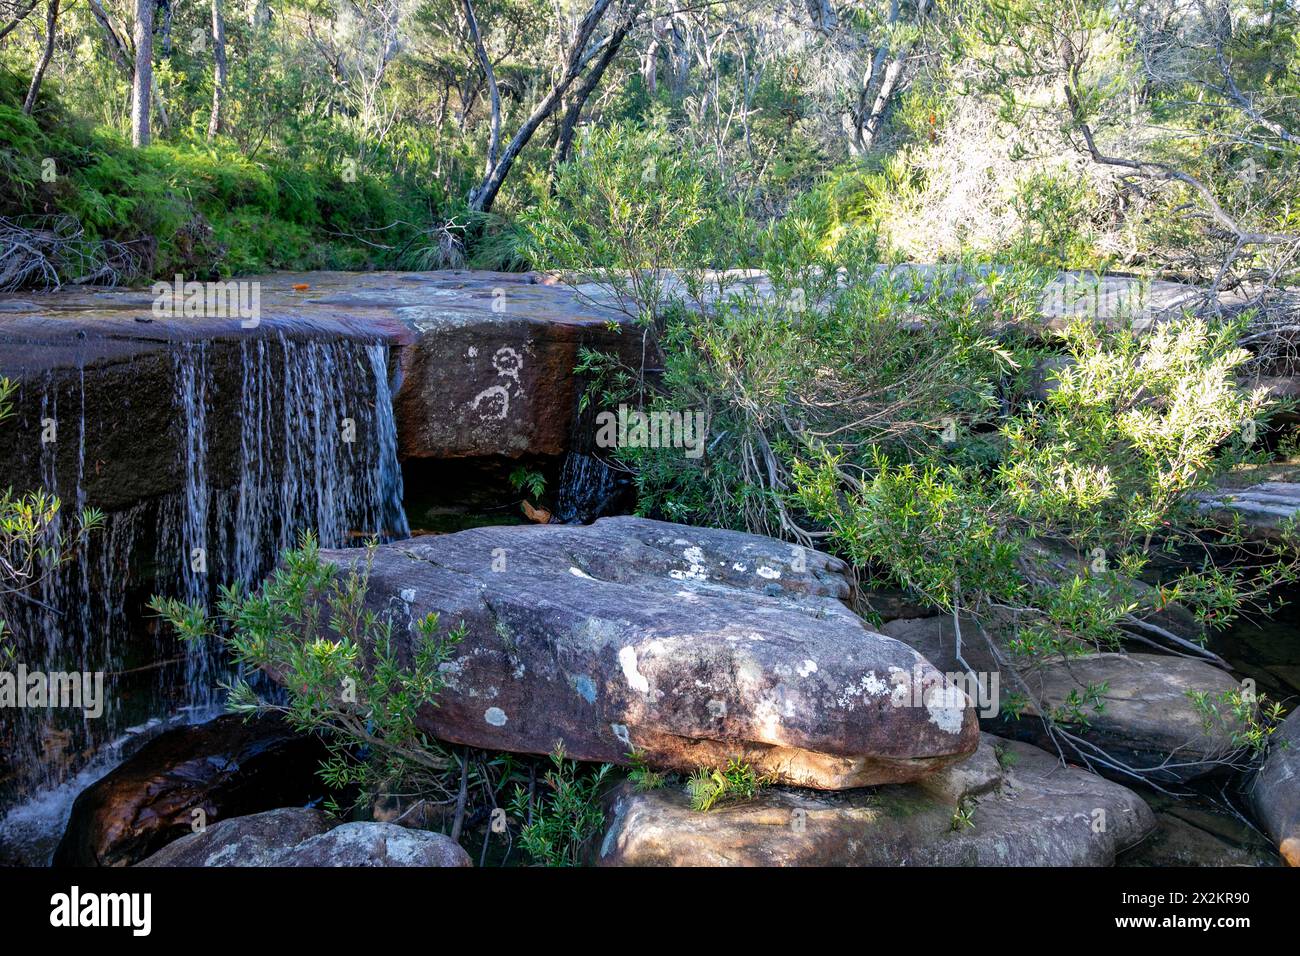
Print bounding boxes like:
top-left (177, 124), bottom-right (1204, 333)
top-left (881, 617), bottom-right (1244, 782)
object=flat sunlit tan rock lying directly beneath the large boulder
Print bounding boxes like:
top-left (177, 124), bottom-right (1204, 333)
top-left (594, 735), bottom-right (1153, 866)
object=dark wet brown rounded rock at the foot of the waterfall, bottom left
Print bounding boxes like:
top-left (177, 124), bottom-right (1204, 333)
top-left (53, 715), bottom-right (328, 866)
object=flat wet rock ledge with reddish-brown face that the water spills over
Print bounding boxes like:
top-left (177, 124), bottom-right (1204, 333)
top-left (0, 272), bottom-right (647, 510)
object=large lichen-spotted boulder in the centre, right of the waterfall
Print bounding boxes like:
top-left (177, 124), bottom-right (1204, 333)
top-left (312, 518), bottom-right (978, 790)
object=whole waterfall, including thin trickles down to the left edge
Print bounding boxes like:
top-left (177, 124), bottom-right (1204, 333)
top-left (0, 332), bottom-right (410, 806)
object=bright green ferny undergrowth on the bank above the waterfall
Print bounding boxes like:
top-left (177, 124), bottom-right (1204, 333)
top-left (0, 74), bottom-right (460, 281)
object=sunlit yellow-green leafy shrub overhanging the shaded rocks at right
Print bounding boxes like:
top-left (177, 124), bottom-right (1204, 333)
top-left (796, 319), bottom-right (1297, 656)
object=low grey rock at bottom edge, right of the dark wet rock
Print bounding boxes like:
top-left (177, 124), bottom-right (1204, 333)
top-left (139, 809), bottom-right (472, 866)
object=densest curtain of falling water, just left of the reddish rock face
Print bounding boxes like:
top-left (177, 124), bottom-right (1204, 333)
top-left (156, 333), bottom-right (410, 709)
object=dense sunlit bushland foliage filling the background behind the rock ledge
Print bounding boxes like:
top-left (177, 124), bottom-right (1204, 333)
top-left (0, 0), bottom-right (1300, 284)
